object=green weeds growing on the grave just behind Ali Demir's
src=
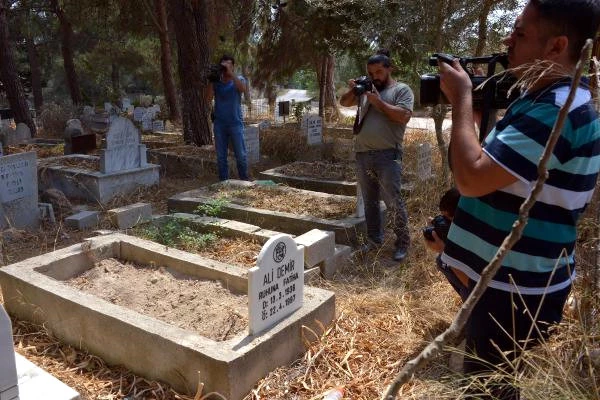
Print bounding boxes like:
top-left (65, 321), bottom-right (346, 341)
top-left (137, 218), bottom-right (218, 251)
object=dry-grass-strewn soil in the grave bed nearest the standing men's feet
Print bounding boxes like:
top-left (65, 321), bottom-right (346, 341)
top-left (213, 185), bottom-right (356, 219)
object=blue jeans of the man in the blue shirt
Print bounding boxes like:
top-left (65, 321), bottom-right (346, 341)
top-left (213, 122), bottom-right (250, 181)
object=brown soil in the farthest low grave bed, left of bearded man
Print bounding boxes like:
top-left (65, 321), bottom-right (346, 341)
top-left (277, 161), bottom-right (356, 182)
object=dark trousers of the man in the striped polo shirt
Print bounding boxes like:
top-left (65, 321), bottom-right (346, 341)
top-left (464, 281), bottom-right (571, 400)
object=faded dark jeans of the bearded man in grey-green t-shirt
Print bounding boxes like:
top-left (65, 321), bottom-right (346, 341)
top-left (356, 149), bottom-right (410, 250)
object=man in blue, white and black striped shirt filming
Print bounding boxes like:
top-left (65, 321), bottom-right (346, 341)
top-left (440, 0), bottom-right (600, 399)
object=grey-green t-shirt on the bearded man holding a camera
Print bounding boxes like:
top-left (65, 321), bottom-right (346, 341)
top-left (354, 82), bottom-right (414, 153)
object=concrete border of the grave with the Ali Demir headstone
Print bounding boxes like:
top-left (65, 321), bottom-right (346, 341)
top-left (0, 234), bottom-right (335, 400)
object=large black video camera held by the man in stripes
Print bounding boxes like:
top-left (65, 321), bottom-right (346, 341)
top-left (419, 53), bottom-right (519, 110)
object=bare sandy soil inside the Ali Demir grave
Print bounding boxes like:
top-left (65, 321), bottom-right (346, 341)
top-left (67, 258), bottom-right (248, 341)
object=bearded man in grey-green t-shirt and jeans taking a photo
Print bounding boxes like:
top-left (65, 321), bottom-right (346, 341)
top-left (340, 50), bottom-right (414, 262)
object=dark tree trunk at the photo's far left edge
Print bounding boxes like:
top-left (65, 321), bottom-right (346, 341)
top-left (0, 0), bottom-right (36, 137)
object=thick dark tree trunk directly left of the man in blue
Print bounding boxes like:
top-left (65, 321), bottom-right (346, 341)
top-left (169, 0), bottom-right (212, 146)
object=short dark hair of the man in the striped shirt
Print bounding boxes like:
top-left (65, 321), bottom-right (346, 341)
top-left (529, 0), bottom-right (600, 61)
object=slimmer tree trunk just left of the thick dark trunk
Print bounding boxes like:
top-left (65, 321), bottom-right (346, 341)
top-left (154, 0), bottom-right (181, 122)
